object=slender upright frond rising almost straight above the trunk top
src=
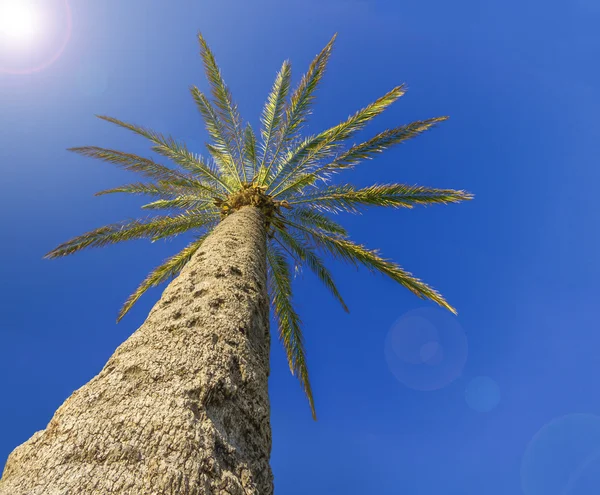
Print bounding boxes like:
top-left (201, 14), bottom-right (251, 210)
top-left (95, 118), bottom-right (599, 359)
top-left (258, 60), bottom-right (292, 185)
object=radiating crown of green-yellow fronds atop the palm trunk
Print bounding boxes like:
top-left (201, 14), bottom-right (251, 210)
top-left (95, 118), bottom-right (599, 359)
top-left (46, 35), bottom-right (472, 416)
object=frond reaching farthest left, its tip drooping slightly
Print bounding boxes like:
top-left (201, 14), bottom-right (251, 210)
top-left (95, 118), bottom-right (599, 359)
top-left (45, 212), bottom-right (219, 258)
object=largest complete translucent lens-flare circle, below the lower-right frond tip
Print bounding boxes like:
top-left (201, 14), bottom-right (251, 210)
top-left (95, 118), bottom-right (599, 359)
top-left (384, 308), bottom-right (468, 391)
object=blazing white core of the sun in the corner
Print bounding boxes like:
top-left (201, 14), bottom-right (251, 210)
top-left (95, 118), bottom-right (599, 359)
top-left (0, 0), bottom-right (40, 44)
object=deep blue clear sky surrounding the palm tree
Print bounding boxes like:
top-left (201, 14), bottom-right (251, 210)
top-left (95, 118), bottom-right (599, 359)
top-left (0, 0), bottom-right (600, 495)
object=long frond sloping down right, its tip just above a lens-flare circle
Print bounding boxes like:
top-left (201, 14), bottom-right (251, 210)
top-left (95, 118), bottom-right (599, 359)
top-left (283, 220), bottom-right (456, 314)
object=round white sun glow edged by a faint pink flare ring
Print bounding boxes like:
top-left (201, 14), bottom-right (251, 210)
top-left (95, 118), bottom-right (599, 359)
top-left (0, 0), bottom-right (72, 74)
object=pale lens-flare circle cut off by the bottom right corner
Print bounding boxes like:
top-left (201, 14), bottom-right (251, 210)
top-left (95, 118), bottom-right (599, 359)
top-left (521, 414), bottom-right (600, 495)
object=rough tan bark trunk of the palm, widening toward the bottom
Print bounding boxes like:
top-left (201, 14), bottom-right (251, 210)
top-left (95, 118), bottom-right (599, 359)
top-left (0, 206), bottom-right (273, 495)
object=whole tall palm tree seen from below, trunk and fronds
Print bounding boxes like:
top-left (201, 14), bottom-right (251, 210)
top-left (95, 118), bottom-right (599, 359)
top-left (0, 36), bottom-right (472, 495)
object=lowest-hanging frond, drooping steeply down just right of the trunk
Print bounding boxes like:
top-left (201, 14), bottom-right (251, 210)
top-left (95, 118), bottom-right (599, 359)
top-left (267, 242), bottom-right (317, 420)
